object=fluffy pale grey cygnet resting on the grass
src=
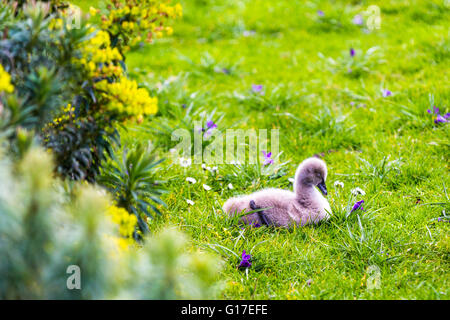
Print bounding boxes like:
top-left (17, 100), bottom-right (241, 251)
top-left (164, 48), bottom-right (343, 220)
top-left (223, 158), bottom-right (331, 227)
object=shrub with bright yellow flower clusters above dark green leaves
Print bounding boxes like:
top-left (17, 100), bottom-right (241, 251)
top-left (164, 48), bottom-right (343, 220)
top-left (34, 0), bottom-right (178, 182)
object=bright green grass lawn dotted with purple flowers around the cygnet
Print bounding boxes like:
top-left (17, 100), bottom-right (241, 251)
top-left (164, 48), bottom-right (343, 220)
top-left (75, 0), bottom-right (450, 299)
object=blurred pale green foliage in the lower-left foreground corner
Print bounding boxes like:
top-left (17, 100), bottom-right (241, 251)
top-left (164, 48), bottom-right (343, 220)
top-left (0, 147), bottom-right (220, 299)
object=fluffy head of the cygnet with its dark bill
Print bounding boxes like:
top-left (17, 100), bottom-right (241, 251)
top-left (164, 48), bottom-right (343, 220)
top-left (294, 158), bottom-right (328, 196)
